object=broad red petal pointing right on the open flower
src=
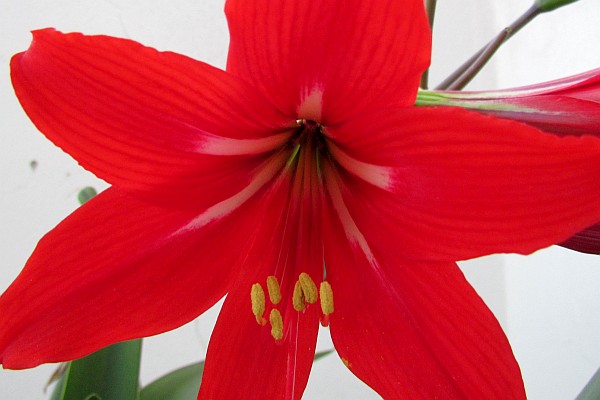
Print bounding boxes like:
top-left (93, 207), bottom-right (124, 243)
top-left (328, 108), bottom-right (600, 261)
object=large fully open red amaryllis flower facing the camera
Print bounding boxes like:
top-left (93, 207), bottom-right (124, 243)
top-left (0, 0), bottom-right (600, 399)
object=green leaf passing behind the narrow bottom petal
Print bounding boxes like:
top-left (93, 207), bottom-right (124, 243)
top-left (138, 349), bottom-right (333, 400)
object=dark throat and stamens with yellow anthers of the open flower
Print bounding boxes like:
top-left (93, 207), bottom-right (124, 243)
top-left (250, 119), bottom-right (334, 342)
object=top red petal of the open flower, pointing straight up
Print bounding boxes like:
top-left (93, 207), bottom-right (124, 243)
top-left (225, 0), bottom-right (431, 125)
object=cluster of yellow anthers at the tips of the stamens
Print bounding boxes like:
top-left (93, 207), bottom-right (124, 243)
top-left (250, 272), bottom-right (333, 342)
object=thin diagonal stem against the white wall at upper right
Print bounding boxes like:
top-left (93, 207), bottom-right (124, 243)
top-left (436, 4), bottom-right (543, 90)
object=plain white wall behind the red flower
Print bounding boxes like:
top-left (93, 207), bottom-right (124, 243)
top-left (0, 0), bottom-right (600, 400)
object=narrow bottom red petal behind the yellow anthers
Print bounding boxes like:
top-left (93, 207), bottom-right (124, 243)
top-left (198, 172), bottom-right (323, 400)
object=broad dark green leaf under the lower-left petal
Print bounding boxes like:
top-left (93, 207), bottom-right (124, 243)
top-left (51, 339), bottom-right (142, 400)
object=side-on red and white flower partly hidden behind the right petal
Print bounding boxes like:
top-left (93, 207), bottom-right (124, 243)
top-left (417, 69), bottom-right (600, 254)
